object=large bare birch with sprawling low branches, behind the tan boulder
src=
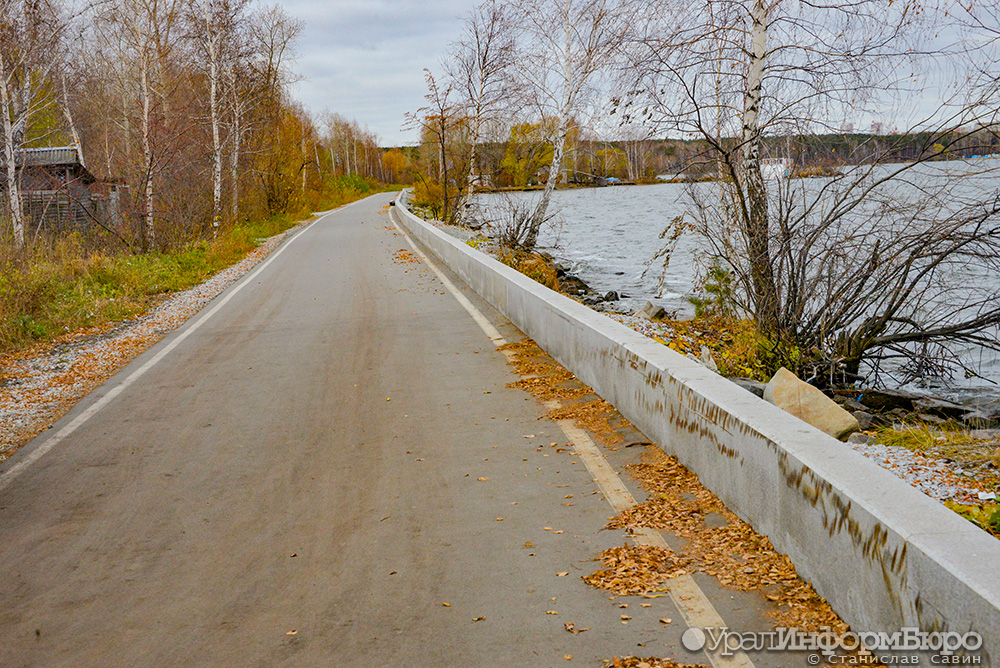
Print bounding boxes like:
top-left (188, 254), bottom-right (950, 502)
top-left (632, 0), bottom-right (1000, 384)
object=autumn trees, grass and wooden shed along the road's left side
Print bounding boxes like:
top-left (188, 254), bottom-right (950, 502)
top-left (0, 0), bottom-right (405, 354)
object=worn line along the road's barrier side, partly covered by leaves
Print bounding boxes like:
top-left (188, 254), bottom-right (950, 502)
top-left (393, 211), bottom-right (754, 668)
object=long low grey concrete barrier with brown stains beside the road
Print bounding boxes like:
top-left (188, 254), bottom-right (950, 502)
top-left (396, 200), bottom-right (1000, 666)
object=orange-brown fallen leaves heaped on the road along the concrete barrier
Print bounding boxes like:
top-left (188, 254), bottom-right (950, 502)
top-left (506, 339), bottom-right (847, 632)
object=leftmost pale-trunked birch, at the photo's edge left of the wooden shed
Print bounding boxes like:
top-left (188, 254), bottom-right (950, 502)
top-left (0, 0), bottom-right (65, 248)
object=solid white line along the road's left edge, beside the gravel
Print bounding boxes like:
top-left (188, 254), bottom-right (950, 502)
top-left (0, 211), bottom-right (333, 490)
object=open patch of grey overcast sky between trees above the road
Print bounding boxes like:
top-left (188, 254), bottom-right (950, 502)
top-left (280, 0), bottom-right (478, 146)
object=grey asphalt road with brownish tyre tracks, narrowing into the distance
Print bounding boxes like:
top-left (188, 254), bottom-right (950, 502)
top-left (0, 195), bottom-right (772, 668)
